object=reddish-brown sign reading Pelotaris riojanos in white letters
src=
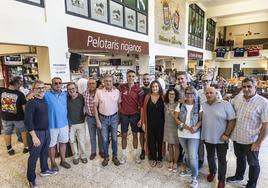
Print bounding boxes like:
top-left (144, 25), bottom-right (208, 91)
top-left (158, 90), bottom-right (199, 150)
top-left (67, 27), bottom-right (149, 54)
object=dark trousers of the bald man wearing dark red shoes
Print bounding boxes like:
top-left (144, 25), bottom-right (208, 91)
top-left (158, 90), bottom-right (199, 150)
top-left (205, 142), bottom-right (228, 181)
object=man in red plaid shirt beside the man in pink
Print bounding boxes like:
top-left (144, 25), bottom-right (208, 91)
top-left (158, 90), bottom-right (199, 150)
top-left (84, 78), bottom-right (104, 160)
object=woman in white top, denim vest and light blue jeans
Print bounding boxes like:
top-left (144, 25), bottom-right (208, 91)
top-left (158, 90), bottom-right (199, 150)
top-left (174, 86), bottom-right (202, 188)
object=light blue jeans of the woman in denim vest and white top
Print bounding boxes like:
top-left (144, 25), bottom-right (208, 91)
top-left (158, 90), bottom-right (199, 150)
top-left (179, 137), bottom-right (200, 178)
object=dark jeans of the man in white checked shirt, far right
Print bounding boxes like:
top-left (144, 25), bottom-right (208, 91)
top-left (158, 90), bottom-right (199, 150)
top-left (234, 142), bottom-right (260, 188)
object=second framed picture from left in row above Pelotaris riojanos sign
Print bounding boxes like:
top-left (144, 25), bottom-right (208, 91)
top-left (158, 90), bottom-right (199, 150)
top-left (90, 0), bottom-right (108, 23)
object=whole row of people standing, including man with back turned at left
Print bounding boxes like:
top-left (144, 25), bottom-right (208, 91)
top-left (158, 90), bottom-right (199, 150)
top-left (0, 70), bottom-right (268, 188)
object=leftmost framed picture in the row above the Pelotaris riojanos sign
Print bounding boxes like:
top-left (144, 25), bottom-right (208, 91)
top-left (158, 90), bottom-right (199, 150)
top-left (65, 0), bottom-right (88, 18)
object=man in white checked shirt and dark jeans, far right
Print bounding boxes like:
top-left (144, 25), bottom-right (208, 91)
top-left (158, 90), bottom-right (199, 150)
top-left (227, 78), bottom-right (268, 188)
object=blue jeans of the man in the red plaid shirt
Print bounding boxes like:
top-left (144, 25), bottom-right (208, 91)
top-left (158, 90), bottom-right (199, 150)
top-left (87, 116), bottom-right (103, 154)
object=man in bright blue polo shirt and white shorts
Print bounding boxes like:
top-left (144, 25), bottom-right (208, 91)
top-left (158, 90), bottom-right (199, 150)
top-left (45, 77), bottom-right (71, 171)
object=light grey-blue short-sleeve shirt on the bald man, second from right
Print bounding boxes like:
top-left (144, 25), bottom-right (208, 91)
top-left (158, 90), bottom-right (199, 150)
top-left (201, 100), bottom-right (236, 144)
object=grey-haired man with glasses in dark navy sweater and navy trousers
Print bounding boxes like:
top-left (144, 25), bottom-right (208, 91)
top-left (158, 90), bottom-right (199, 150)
top-left (24, 80), bottom-right (57, 187)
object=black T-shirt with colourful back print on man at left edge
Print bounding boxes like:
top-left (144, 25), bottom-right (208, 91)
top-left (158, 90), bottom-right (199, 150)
top-left (0, 88), bottom-right (26, 121)
